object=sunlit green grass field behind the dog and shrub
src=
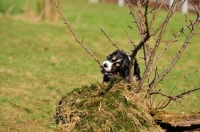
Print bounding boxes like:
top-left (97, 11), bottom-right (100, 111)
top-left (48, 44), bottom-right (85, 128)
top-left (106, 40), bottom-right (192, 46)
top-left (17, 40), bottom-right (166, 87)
top-left (0, 0), bottom-right (200, 132)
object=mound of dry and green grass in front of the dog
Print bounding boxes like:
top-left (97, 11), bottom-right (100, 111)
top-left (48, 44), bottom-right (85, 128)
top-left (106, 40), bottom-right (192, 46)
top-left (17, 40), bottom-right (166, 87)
top-left (55, 80), bottom-right (161, 131)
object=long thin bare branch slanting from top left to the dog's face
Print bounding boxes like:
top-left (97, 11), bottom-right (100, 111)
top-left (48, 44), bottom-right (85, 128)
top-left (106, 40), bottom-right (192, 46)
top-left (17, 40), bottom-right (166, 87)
top-left (52, 0), bottom-right (101, 67)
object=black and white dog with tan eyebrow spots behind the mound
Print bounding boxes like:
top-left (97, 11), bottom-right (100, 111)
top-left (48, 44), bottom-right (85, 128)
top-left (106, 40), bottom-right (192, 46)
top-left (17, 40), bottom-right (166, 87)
top-left (101, 50), bottom-right (141, 82)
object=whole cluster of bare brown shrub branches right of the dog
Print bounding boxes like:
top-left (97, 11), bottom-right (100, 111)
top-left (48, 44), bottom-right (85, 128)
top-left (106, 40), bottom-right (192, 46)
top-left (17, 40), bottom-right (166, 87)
top-left (126, 0), bottom-right (200, 109)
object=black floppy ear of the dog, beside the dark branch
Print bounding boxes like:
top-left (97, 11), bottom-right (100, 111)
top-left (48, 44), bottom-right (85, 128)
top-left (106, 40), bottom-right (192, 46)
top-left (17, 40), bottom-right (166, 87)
top-left (120, 54), bottom-right (130, 78)
